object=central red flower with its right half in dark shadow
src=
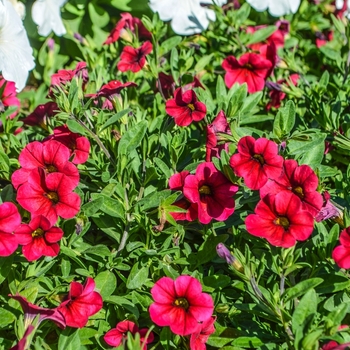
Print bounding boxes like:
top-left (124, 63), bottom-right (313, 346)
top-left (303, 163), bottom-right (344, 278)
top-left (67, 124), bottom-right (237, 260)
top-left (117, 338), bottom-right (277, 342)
top-left (183, 162), bottom-right (238, 224)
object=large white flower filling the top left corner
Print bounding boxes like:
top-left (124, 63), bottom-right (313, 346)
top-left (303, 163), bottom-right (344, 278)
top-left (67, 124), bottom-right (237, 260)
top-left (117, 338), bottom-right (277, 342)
top-left (0, 0), bottom-right (35, 91)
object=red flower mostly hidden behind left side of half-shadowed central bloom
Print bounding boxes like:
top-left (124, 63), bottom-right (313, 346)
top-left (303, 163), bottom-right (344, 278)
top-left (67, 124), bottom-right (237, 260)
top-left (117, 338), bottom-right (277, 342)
top-left (169, 170), bottom-right (198, 221)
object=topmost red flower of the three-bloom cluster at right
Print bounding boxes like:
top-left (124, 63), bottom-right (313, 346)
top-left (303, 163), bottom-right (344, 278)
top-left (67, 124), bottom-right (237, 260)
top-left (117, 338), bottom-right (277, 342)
top-left (230, 136), bottom-right (283, 190)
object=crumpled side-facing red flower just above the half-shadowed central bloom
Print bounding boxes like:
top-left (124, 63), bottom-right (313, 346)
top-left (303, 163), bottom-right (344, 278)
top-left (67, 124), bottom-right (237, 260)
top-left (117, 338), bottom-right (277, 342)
top-left (205, 111), bottom-right (231, 162)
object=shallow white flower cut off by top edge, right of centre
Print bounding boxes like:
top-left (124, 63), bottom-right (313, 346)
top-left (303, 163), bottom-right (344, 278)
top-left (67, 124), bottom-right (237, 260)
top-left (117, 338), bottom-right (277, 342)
top-left (247, 0), bottom-right (300, 17)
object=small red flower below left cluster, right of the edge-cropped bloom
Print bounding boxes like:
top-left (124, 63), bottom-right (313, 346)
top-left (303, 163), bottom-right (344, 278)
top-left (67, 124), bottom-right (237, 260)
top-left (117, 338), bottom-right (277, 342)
top-left (15, 215), bottom-right (63, 261)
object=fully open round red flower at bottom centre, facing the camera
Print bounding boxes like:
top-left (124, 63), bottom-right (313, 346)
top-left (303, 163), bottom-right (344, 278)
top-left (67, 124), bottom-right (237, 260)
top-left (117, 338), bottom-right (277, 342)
top-left (149, 276), bottom-right (214, 335)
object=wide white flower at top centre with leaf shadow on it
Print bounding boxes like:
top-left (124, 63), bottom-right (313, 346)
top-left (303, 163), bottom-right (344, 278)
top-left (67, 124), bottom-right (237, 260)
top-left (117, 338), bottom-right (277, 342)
top-left (149, 0), bottom-right (227, 35)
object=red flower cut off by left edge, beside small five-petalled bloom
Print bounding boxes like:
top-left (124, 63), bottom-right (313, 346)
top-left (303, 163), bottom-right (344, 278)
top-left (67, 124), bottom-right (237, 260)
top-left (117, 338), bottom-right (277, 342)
top-left (0, 202), bottom-right (21, 256)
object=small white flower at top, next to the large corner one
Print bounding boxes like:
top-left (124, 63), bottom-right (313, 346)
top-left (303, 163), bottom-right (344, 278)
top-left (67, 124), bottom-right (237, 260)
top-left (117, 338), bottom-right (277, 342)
top-left (32, 0), bottom-right (67, 36)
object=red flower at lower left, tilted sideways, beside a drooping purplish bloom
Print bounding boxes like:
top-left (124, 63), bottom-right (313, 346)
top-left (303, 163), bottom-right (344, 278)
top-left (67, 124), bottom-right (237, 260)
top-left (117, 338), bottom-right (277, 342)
top-left (57, 277), bottom-right (103, 328)
